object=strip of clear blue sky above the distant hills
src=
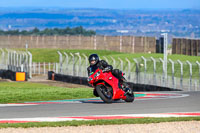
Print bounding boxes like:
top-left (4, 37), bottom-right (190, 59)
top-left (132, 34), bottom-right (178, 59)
top-left (0, 0), bottom-right (200, 9)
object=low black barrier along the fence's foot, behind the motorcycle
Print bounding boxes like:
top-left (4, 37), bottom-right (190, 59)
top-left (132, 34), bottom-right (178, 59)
top-left (48, 71), bottom-right (181, 91)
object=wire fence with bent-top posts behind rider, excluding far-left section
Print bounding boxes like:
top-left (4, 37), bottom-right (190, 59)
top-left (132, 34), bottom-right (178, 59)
top-left (54, 51), bottom-right (200, 91)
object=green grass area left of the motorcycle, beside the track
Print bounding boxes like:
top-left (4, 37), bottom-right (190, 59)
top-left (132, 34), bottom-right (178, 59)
top-left (0, 82), bottom-right (94, 103)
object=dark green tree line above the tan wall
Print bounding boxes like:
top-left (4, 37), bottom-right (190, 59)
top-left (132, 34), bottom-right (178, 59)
top-left (0, 26), bottom-right (96, 36)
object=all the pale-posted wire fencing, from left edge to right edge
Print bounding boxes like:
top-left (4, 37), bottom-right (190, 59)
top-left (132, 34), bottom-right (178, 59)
top-left (0, 49), bottom-right (200, 91)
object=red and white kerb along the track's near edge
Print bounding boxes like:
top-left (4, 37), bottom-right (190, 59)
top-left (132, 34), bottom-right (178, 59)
top-left (0, 112), bottom-right (200, 123)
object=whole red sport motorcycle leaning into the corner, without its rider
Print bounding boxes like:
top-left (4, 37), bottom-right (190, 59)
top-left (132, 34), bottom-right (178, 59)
top-left (88, 69), bottom-right (134, 103)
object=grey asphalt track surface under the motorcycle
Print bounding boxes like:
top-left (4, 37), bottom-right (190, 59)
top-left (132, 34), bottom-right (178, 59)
top-left (0, 91), bottom-right (200, 119)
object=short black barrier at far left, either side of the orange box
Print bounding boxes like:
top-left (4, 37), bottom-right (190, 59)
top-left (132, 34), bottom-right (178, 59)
top-left (0, 70), bottom-right (28, 81)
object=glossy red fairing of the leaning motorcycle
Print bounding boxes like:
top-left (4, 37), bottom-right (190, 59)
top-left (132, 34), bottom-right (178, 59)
top-left (88, 69), bottom-right (126, 100)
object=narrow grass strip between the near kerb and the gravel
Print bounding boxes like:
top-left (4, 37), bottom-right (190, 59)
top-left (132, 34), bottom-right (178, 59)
top-left (0, 117), bottom-right (200, 128)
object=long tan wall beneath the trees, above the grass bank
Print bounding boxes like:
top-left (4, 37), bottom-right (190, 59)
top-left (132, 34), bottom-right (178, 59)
top-left (0, 36), bottom-right (156, 53)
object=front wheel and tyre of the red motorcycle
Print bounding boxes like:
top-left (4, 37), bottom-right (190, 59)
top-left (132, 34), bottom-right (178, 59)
top-left (96, 85), bottom-right (113, 103)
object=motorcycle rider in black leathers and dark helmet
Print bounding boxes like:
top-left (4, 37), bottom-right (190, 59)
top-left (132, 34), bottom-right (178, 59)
top-left (87, 54), bottom-right (129, 96)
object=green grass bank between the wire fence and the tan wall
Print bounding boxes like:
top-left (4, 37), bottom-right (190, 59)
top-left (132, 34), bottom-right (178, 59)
top-left (17, 48), bottom-right (200, 62)
